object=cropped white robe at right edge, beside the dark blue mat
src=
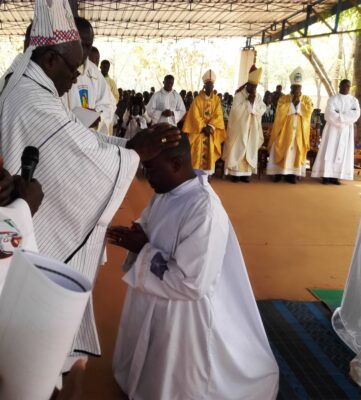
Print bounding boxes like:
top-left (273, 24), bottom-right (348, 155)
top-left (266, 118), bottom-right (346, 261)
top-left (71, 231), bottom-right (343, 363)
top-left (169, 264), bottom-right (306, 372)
top-left (332, 224), bottom-right (361, 386)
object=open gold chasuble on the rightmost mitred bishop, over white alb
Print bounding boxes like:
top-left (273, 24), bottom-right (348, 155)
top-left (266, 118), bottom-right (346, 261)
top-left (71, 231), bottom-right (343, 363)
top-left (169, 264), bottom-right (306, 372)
top-left (268, 95), bottom-right (313, 168)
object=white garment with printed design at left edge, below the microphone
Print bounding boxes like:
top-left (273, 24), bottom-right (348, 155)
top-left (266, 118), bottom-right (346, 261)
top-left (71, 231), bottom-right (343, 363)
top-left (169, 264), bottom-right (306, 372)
top-left (0, 199), bottom-right (38, 294)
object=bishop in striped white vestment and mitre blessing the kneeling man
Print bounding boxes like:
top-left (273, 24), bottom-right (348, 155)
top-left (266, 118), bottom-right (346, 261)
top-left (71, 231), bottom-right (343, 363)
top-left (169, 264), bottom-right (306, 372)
top-left (0, 0), bottom-right (179, 366)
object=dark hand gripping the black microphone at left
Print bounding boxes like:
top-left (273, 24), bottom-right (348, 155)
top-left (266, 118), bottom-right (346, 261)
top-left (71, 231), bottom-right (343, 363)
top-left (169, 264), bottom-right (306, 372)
top-left (13, 175), bottom-right (44, 215)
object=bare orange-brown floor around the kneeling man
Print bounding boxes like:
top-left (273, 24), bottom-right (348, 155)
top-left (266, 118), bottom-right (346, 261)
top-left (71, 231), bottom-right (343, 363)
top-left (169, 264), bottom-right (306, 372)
top-left (79, 176), bottom-right (361, 400)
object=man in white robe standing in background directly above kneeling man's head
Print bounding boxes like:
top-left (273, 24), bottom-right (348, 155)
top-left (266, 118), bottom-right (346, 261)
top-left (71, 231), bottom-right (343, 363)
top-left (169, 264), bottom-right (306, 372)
top-left (146, 75), bottom-right (186, 126)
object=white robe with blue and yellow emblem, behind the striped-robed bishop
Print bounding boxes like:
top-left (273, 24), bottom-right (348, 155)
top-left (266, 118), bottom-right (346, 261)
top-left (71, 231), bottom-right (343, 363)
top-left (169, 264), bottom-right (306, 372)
top-left (62, 58), bottom-right (116, 134)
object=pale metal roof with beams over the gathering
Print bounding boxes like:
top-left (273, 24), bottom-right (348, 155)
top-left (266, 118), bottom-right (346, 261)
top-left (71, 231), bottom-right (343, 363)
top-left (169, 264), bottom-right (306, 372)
top-left (0, 0), bottom-right (352, 39)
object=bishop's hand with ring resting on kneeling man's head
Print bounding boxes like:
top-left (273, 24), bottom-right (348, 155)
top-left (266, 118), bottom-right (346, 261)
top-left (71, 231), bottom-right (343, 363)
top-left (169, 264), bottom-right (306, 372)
top-left (126, 124), bottom-right (181, 162)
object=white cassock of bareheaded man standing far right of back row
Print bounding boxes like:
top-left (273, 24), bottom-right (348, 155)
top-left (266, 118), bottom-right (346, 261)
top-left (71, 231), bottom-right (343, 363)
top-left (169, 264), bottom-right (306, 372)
top-left (311, 93), bottom-right (360, 180)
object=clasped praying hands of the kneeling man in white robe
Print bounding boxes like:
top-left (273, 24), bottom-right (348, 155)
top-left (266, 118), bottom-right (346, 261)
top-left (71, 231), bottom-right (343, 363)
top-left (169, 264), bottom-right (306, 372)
top-left (107, 222), bottom-right (149, 254)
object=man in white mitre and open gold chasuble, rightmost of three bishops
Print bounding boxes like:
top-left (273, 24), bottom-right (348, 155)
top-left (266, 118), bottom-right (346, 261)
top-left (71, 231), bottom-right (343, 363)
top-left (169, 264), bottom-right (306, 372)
top-left (267, 67), bottom-right (313, 184)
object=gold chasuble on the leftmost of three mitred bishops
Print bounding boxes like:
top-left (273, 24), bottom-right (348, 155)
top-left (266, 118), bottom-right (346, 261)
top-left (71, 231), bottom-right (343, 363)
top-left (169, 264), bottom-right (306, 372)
top-left (183, 90), bottom-right (226, 171)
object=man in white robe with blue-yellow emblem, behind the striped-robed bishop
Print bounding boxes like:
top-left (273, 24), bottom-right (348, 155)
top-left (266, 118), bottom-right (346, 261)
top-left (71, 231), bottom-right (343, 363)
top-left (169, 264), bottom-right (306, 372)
top-left (63, 17), bottom-right (116, 135)
